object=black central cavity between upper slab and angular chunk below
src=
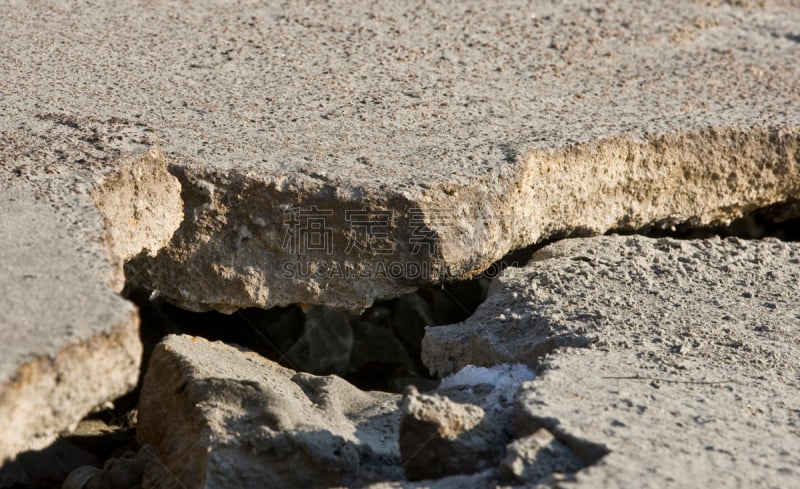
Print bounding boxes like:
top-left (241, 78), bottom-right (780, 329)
top-left (126, 277), bottom-right (489, 392)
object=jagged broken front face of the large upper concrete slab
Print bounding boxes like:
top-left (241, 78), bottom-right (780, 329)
top-left (127, 127), bottom-right (800, 312)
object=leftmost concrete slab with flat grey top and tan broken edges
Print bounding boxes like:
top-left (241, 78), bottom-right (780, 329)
top-left (0, 146), bottom-right (182, 461)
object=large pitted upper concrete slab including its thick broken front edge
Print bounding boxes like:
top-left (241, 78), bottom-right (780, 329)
top-left (0, 0), bottom-right (800, 311)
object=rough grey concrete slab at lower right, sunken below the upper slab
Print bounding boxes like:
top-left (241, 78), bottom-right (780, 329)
top-left (423, 236), bottom-right (800, 487)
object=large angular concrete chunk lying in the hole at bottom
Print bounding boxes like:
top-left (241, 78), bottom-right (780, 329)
top-left (137, 336), bottom-right (402, 489)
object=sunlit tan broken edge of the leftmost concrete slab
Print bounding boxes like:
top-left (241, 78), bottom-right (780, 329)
top-left (0, 148), bottom-right (183, 463)
